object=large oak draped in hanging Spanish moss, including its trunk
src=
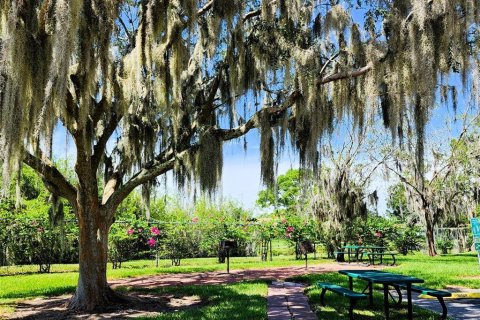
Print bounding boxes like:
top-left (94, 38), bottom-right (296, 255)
top-left (0, 0), bottom-right (480, 310)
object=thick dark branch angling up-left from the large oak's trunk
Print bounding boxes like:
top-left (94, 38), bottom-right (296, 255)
top-left (23, 151), bottom-right (77, 203)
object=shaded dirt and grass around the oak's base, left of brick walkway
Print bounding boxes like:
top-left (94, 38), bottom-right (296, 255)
top-left (9, 281), bottom-right (267, 320)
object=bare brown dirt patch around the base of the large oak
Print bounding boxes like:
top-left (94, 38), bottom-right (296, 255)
top-left (8, 292), bottom-right (206, 320)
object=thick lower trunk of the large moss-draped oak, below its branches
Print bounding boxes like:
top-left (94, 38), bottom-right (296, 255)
top-left (68, 211), bottom-right (123, 311)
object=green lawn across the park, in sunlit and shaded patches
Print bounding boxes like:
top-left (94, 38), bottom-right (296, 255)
top-left (0, 254), bottom-right (480, 319)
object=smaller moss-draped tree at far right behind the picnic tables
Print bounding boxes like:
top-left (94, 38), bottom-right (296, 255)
top-left (384, 115), bottom-right (479, 256)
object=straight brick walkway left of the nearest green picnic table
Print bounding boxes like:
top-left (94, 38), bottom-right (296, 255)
top-left (267, 281), bottom-right (317, 320)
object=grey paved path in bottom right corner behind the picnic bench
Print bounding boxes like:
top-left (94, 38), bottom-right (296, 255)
top-left (412, 294), bottom-right (480, 320)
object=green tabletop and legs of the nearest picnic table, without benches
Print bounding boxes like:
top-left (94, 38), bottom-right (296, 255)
top-left (339, 270), bottom-right (424, 320)
